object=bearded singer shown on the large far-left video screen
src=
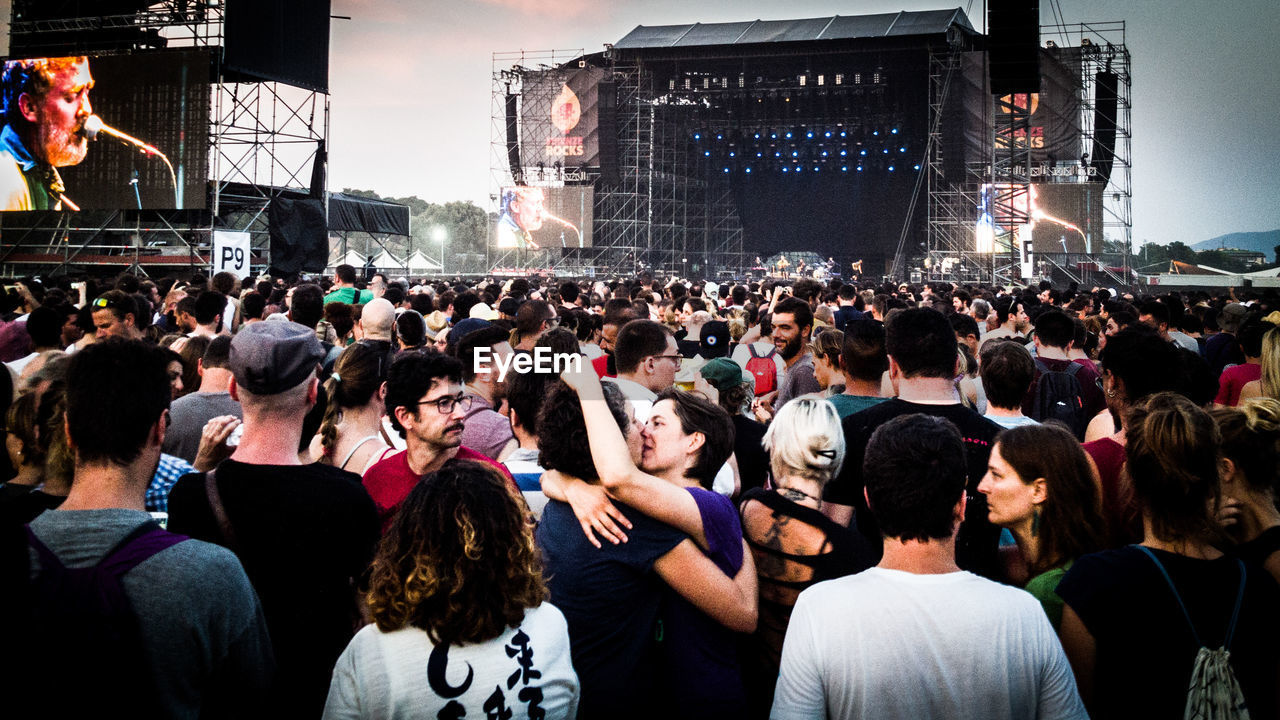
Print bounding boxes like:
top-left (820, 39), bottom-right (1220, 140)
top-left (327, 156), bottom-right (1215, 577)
top-left (0, 56), bottom-right (93, 210)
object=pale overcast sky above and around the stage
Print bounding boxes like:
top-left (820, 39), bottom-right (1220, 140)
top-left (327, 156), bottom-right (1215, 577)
top-left (330, 0), bottom-right (1280, 243)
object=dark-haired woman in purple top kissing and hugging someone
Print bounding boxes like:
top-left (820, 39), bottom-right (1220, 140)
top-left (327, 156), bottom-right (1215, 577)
top-left (543, 361), bottom-right (756, 717)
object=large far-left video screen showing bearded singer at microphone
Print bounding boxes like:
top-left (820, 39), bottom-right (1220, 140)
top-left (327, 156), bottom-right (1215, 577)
top-left (0, 50), bottom-right (210, 210)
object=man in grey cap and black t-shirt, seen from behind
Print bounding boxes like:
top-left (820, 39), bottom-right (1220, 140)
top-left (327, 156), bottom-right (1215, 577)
top-left (169, 323), bottom-right (378, 716)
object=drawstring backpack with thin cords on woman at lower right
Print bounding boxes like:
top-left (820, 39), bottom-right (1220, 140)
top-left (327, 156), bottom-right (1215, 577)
top-left (1137, 544), bottom-right (1249, 720)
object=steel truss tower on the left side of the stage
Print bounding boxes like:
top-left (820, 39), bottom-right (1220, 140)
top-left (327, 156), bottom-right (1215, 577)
top-left (491, 50), bottom-right (742, 277)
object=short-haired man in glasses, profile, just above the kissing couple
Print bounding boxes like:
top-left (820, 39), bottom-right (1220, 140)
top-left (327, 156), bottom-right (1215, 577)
top-left (607, 320), bottom-right (684, 423)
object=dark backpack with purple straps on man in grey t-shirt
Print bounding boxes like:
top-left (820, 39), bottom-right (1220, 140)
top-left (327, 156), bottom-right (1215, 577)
top-left (19, 520), bottom-right (188, 717)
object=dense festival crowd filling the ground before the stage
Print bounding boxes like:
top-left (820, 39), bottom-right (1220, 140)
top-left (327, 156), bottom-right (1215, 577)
top-left (0, 265), bottom-right (1280, 720)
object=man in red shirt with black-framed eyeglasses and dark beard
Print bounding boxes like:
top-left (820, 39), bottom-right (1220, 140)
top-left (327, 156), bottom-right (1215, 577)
top-left (365, 351), bottom-right (516, 533)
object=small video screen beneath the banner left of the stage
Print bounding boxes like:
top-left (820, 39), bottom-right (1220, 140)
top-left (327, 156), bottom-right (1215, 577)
top-left (493, 186), bottom-right (595, 250)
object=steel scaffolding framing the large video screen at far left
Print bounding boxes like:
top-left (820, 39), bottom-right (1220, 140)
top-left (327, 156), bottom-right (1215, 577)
top-left (0, 0), bottom-right (329, 274)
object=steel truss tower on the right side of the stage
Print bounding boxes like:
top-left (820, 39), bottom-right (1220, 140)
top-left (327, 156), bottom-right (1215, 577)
top-left (916, 20), bottom-right (1133, 286)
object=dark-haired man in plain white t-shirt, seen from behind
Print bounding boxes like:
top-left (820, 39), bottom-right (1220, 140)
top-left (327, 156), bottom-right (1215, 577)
top-left (769, 414), bottom-right (1088, 720)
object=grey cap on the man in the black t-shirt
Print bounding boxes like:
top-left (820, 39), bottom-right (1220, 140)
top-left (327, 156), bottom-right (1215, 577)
top-left (228, 322), bottom-right (324, 395)
